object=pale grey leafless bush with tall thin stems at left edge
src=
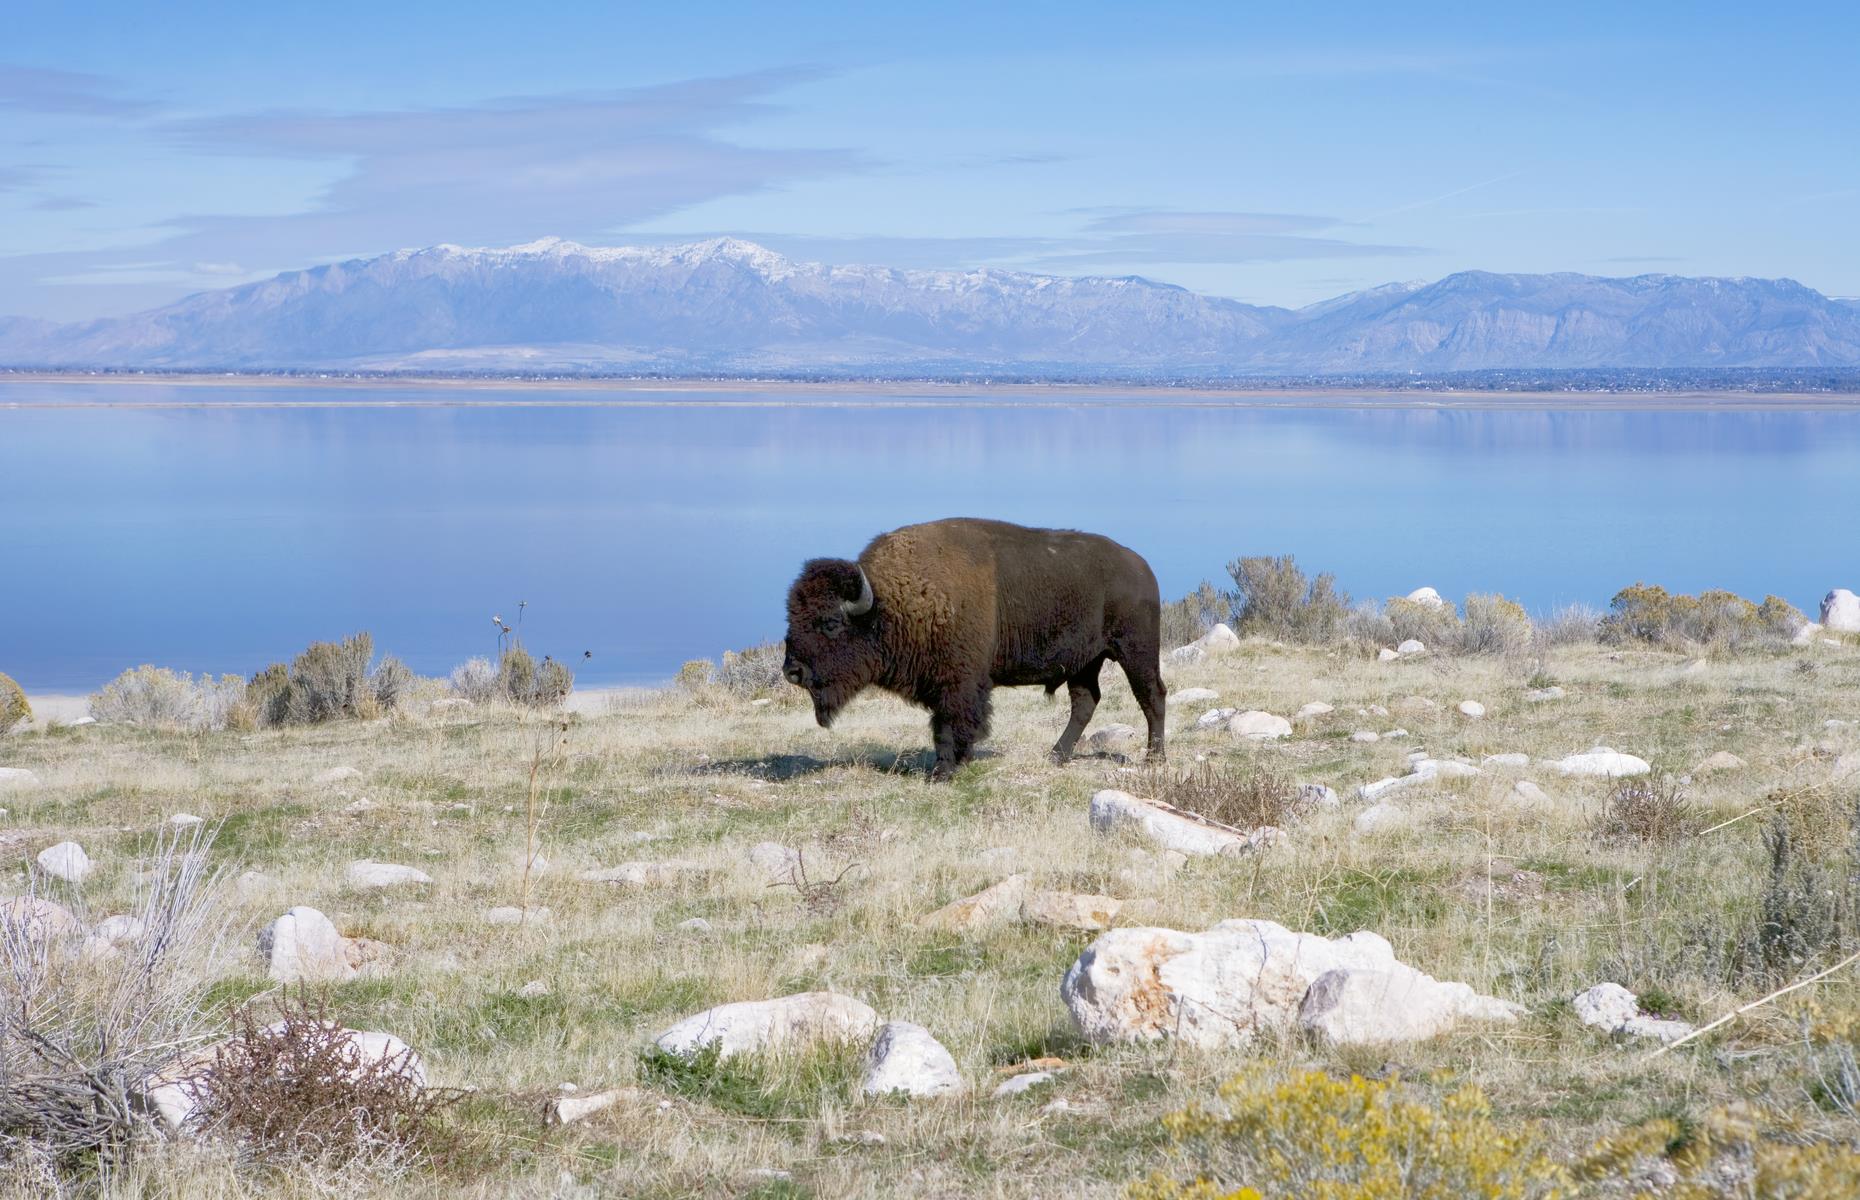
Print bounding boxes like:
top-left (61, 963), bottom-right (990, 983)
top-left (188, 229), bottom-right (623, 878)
top-left (0, 830), bottom-right (229, 1172)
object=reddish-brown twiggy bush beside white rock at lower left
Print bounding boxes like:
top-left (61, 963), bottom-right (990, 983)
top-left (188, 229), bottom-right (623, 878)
top-left (192, 990), bottom-right (459, 1167)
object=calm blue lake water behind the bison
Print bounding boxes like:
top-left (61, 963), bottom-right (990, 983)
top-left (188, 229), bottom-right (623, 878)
top-left (0, 383), bottom-right (1860, 690)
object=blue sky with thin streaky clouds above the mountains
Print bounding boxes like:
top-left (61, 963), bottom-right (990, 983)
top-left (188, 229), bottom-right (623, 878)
top-left (0, 0), bottom-right (1860, 320)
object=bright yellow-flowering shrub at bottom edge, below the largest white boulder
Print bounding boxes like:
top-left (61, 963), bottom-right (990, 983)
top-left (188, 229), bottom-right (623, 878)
top-left (1129, 1068), bottom-right (1568, 1200)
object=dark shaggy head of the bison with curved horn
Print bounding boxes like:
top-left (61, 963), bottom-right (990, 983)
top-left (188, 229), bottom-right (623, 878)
top-left (781, 558), bottom-right (882, 726)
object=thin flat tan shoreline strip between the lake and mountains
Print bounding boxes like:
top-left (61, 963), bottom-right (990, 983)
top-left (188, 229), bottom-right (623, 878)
top-left (0, 372), bottom-right (1860, 411)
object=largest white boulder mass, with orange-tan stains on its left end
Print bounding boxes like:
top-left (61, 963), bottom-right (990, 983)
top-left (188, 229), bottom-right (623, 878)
top-left (1060, 921), bottom-right (1516, 1049)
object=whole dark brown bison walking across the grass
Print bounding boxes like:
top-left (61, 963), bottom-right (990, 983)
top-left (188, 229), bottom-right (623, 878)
top-left (781, 517), bottom-right (1166, 780)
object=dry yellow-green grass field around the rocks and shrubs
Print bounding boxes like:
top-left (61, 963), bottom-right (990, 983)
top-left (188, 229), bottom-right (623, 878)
top-left (0, 640), bottom-right (1860, 1196)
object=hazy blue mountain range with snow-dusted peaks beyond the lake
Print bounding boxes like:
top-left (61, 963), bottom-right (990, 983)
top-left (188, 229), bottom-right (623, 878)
top-left (0, 238), bottom-right (1860, 378)
